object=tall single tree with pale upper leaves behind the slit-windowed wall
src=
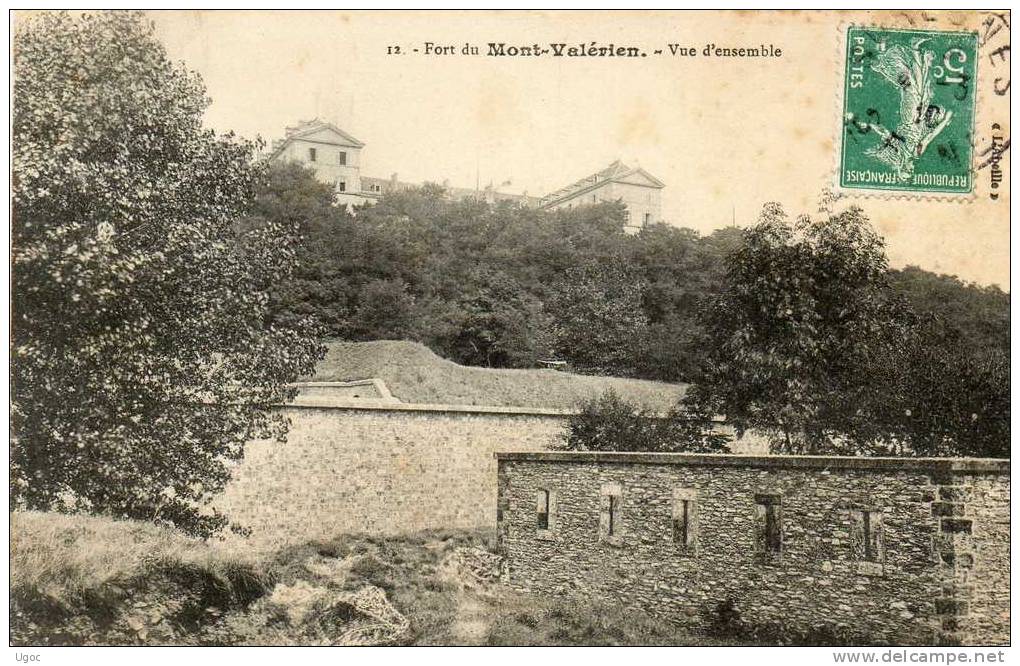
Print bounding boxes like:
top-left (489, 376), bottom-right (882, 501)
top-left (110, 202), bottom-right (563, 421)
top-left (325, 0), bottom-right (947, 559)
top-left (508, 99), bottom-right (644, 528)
top-left (692, 204), bottom-right (907, 453)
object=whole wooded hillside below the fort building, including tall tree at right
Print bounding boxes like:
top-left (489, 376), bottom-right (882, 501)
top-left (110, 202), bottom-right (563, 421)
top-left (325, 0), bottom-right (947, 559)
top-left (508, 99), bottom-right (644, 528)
top-left (265, 165), bottom-right (1010, 455)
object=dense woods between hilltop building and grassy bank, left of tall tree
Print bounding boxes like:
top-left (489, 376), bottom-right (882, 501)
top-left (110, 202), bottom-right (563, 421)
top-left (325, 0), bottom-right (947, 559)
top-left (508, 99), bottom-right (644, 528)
top-left (259, 164), bottom-right (738, 380)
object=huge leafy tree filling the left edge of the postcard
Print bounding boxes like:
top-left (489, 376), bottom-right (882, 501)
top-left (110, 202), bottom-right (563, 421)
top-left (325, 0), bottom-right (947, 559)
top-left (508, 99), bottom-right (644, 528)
top-left (10, 12), bottom-right (320, 535)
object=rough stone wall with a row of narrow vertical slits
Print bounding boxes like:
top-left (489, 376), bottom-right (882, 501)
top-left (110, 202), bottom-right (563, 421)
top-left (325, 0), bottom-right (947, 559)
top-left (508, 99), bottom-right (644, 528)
top-left (497, 453), bottom-right (1009, 645)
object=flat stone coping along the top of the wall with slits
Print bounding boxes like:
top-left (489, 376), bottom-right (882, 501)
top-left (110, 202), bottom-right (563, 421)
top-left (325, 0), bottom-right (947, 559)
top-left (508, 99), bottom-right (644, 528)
top-left (494, 451), bottom-right (1010, 474)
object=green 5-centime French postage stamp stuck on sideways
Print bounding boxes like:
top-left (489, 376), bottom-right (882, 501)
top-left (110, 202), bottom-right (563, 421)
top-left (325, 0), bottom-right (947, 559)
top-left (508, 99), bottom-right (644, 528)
top-left (839, 28), bottom-right (977, 194)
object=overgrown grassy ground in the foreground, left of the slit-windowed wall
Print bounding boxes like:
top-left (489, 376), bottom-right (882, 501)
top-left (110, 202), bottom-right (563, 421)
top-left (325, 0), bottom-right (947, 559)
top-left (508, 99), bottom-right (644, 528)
top-left (11, 512), bottom-right (731, 646)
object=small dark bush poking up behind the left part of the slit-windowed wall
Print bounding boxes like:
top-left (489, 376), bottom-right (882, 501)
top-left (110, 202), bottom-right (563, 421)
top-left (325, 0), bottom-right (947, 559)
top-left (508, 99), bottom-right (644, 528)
top-left (561, 391), bottom-right (729, 453)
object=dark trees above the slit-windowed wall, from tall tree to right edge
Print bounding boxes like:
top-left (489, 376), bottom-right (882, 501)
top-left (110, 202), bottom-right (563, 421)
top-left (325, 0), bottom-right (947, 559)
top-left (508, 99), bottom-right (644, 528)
top-left (691, 199), bottom-right (1009, 456)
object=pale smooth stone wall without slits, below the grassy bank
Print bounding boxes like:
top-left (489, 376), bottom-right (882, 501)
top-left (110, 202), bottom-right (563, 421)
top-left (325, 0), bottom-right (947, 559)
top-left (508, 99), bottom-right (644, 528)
top-left (215, 404), bottom-right (566, 546)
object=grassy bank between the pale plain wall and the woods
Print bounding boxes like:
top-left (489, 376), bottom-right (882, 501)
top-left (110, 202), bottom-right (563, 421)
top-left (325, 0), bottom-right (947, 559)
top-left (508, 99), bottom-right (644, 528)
top-left (311, 341), bottom-right (686, 412)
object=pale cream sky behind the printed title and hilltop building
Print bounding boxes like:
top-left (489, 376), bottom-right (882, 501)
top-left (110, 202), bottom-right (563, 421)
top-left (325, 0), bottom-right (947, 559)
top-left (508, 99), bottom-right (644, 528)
top-left (150, 10), bottom-right (1009, 289)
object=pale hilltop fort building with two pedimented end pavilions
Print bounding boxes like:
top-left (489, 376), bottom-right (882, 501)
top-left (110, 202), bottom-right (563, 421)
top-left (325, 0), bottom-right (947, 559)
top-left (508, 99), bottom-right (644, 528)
top-left (269, 119), bottom-right (665, 233)
